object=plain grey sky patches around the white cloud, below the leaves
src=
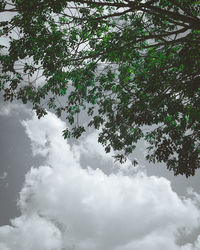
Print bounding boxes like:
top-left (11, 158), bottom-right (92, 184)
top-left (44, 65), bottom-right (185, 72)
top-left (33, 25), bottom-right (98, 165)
top-left (0, 101), bottom-right (200, 225)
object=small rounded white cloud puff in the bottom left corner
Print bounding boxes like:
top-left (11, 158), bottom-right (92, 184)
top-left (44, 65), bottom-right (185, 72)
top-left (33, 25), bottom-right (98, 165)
top-left (0, 214), bottom-right (61, 250)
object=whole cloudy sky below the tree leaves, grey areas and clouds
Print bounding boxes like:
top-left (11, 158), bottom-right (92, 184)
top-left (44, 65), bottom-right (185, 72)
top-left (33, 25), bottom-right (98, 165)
top-left (0, 104), bottom-right (200, 250)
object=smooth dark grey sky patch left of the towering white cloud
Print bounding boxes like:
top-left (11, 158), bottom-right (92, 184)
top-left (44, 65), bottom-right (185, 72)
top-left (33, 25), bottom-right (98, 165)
top-left (0, 102), bottom-right (44, 225)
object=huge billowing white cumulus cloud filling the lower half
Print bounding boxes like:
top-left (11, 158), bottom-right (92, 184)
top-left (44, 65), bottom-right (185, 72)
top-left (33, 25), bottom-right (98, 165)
top-left (0, 113), bottom-right (200, 250)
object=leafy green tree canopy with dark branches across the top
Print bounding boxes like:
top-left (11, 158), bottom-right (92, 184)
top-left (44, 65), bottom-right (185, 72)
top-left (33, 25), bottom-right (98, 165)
top-left (0, 0), bottom-right (200, 177)
